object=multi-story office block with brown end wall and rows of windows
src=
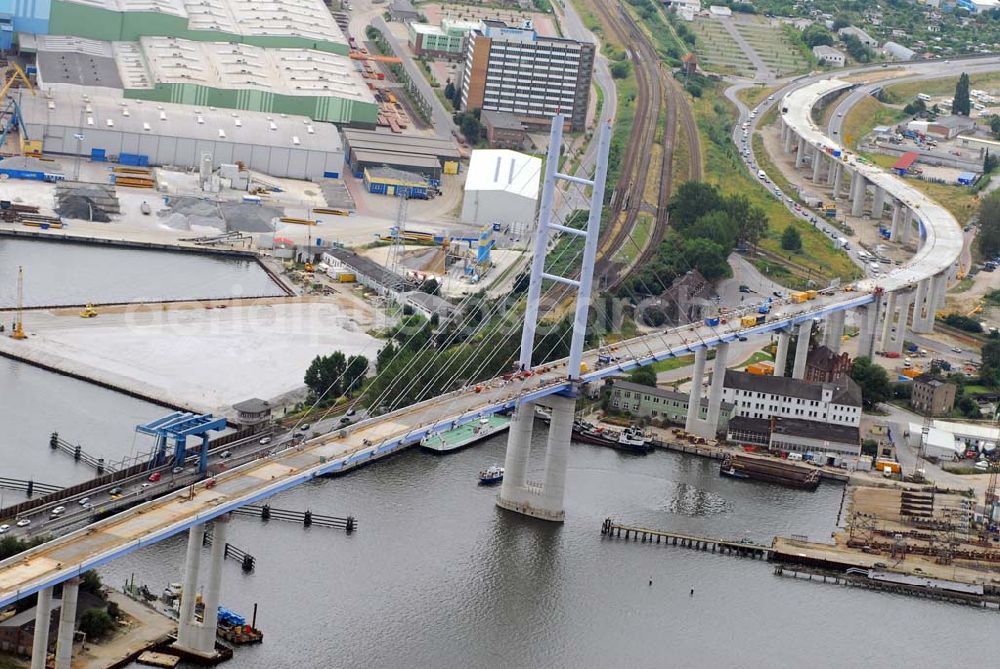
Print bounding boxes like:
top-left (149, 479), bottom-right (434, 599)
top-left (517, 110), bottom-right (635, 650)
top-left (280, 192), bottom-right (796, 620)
top-left (461, 21), bottom-right (594, 131)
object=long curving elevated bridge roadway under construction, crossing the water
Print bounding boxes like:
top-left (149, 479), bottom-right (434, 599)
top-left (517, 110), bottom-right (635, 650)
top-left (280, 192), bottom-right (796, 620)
top-left (0, 69), bottom-right (961, 607)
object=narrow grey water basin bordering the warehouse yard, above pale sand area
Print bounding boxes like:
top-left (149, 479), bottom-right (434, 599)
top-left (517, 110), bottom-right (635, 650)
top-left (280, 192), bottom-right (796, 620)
top-left (0, 237), bottom-right (284, 308)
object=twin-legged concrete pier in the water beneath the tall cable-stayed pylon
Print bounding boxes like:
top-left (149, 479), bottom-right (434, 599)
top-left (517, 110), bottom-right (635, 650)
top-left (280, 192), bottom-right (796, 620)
top-left (496, 395), bottom-right (576, 523)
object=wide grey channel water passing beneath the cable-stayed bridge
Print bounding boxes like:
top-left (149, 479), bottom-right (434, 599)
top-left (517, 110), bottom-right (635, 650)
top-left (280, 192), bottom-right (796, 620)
top-left (0, 368), bottom-right (1000, 669)
